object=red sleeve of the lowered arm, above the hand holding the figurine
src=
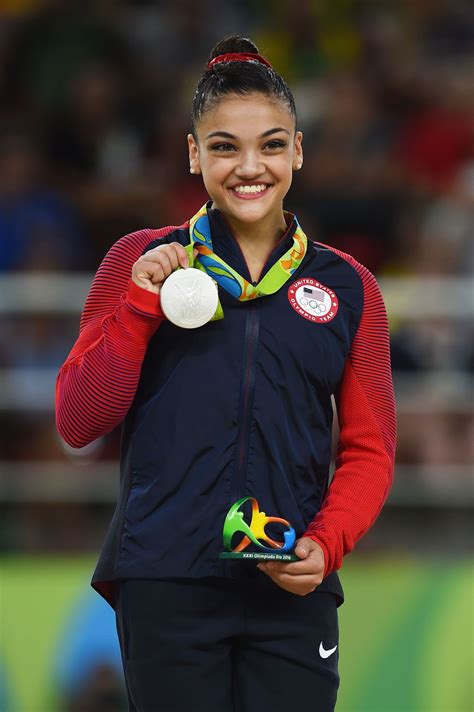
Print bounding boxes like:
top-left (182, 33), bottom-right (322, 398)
top-left (304, 250), bottom-right (396, 576)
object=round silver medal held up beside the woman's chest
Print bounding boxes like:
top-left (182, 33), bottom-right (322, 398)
top-left (160, 267), bottom-right (219, 329)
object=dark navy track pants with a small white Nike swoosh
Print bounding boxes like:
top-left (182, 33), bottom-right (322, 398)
top-left (116, 573), bottom-right (339, 712)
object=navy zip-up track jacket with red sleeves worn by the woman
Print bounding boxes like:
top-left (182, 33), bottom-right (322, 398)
top-left (57, 203), bottom-right (395, 606)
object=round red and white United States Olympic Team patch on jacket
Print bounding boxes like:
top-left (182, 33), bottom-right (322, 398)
top-left (288, 277), bottom-right (339, 324)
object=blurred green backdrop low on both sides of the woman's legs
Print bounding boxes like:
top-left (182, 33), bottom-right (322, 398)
top-left (0, 555), bottom-right (474, 712)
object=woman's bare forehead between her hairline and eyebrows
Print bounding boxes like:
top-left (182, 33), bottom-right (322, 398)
top-left (197, 93), bottom-right (295, 137)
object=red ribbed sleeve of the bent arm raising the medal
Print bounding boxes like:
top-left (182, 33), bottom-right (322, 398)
top-left (56, 227), bottom-right (180, 447)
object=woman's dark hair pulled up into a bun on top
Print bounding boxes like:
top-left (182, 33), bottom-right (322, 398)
top-left (191, 35), bottom-right (296, 138)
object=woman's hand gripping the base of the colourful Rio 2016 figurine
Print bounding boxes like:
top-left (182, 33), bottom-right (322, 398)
top-left (257, 536), bottom-right (324, 596)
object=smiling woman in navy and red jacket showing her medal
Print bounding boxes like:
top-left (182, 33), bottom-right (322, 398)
top-left (57, 37), bottom-right (395, 712)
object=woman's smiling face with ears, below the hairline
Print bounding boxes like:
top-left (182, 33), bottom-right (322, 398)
top-left (188, 93), bottom-right (303, 223)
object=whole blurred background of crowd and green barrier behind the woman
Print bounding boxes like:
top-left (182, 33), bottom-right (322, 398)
top-left (0, 0), bottom-right (474, 712)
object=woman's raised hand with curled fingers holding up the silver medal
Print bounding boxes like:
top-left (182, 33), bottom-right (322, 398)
top-left (132, 242), bottom-right (197, 294)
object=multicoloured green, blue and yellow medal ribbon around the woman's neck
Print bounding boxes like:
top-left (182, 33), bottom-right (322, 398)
top-left (181, 205), bottom-right (308, 320)
